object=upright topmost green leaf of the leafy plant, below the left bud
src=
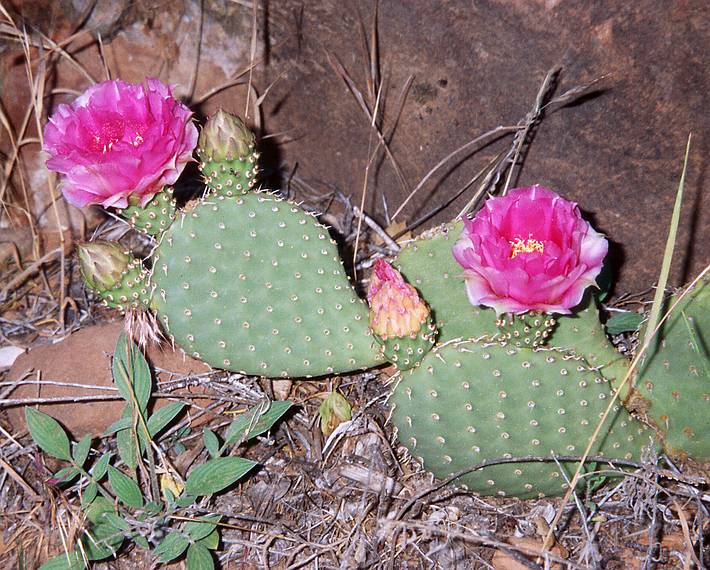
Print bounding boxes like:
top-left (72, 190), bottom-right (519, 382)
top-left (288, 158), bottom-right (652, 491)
top-left (112, 333), bottom-right (151, 416)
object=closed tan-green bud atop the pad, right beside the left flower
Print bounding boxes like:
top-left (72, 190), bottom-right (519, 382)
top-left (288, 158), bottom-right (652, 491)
top-left (197, 109), bottom-right (255, 162)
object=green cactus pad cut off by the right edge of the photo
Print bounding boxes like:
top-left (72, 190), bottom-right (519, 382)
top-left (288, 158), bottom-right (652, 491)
top-left (631, 279), bottom-right (710, 461)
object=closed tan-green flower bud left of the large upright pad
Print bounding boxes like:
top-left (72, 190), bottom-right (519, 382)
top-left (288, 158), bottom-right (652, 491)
top-left (76, 240), bottom-right (132, 291)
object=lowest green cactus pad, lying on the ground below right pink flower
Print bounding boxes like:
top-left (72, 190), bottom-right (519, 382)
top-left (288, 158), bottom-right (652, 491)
top-left (390, 341), bottom-right (651, 498)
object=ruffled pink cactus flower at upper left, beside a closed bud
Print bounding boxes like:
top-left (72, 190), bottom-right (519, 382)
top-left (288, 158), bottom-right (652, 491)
top-left (44, 79), bottom-right (197, 208)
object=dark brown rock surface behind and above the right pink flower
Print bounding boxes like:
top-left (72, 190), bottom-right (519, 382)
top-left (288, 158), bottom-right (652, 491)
top-left (266, 0), bottom-right (710, 292)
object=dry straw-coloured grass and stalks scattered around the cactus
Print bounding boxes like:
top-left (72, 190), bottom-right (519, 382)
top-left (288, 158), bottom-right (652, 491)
top-left (0, 2), bottom-right (710, 569)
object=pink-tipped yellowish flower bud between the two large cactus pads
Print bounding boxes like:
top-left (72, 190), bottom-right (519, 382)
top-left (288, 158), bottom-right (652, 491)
top-left (367, 259), bottom-right (429, 340)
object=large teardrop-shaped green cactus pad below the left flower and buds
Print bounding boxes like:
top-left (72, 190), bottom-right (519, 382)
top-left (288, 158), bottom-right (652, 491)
top-left (152, 193), bottom-right (382, 377)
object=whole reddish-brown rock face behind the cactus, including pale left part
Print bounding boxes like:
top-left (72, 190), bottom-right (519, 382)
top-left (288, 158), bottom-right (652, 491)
top-left (0, 0), bottom-right (710, 292)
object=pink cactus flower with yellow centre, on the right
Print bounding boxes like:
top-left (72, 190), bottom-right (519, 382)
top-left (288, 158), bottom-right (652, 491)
top-left (453, 185), bottom-right (608, 315)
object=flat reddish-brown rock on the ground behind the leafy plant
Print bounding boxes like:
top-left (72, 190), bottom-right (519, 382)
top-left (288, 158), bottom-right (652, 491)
top-left (7, 322), bottom-right (212, 438)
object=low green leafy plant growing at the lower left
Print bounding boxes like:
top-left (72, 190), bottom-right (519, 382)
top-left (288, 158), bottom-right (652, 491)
top-left (25, 335), bottom-right (292, 570)
